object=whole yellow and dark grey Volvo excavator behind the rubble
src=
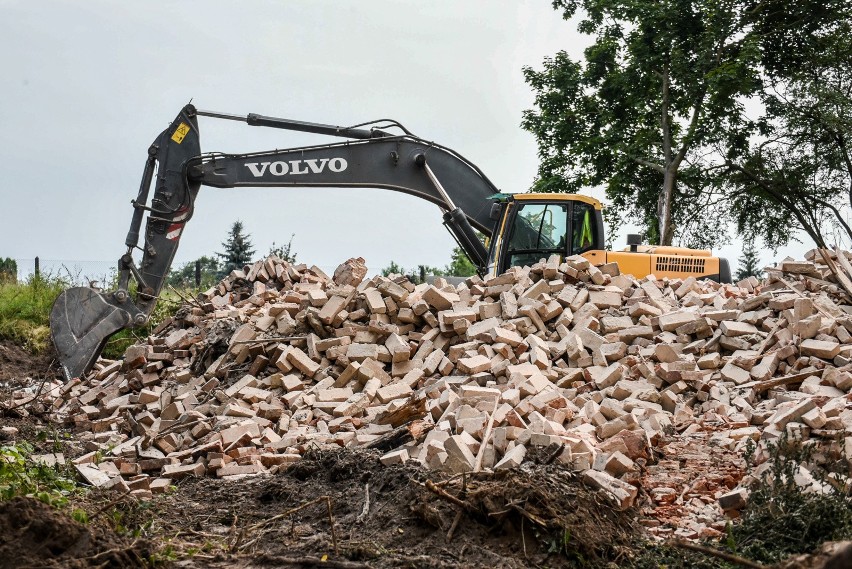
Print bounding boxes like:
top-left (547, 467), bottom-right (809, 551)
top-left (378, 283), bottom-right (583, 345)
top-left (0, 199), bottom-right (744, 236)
top-left (50, 104), bottom-right (731, 380)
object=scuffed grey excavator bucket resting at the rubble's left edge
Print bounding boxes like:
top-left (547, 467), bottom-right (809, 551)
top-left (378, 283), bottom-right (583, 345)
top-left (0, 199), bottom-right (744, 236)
top-left (50, 287), bottom-right (131, 380)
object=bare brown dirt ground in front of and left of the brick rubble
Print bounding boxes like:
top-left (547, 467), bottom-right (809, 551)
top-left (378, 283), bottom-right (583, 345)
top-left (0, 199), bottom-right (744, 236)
top-left (0, 343), bottom-right (843, 569)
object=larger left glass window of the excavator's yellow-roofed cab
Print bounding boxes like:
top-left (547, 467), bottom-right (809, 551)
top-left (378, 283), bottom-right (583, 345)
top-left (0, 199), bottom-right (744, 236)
top-left (508, 203), bottom-right (568, 266)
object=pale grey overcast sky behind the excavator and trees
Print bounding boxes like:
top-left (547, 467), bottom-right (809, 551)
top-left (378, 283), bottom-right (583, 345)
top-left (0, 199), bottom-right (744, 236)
top-left (0, 0), bottom-right (806, 278)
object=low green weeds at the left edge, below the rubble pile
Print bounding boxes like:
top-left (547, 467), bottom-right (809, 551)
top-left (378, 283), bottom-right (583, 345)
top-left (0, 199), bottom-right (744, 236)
top-left (0, 442), bottom-right (78, 506)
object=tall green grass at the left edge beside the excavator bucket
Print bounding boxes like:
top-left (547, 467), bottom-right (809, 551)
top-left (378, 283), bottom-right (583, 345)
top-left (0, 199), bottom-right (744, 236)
top-left (0, 275), bottom-right (65, 353)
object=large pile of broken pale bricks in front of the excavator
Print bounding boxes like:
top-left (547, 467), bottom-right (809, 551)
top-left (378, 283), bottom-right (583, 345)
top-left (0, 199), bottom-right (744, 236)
top-left (18, 252), bottom-right (852, 537)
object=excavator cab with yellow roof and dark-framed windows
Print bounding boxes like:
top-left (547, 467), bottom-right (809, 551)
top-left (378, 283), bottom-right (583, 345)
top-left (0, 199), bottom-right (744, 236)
top-left (488, 194), bottom-right (606, 275)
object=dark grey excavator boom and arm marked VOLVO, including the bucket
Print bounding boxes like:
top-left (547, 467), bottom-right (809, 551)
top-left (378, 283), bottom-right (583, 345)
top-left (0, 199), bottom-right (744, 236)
top-left (50, 105), bottom-right (498, 379)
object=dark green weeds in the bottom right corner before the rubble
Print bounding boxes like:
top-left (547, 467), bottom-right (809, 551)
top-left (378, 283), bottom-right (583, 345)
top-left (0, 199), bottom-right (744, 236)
top-left (731, 436), bottom-right (852, 563)
